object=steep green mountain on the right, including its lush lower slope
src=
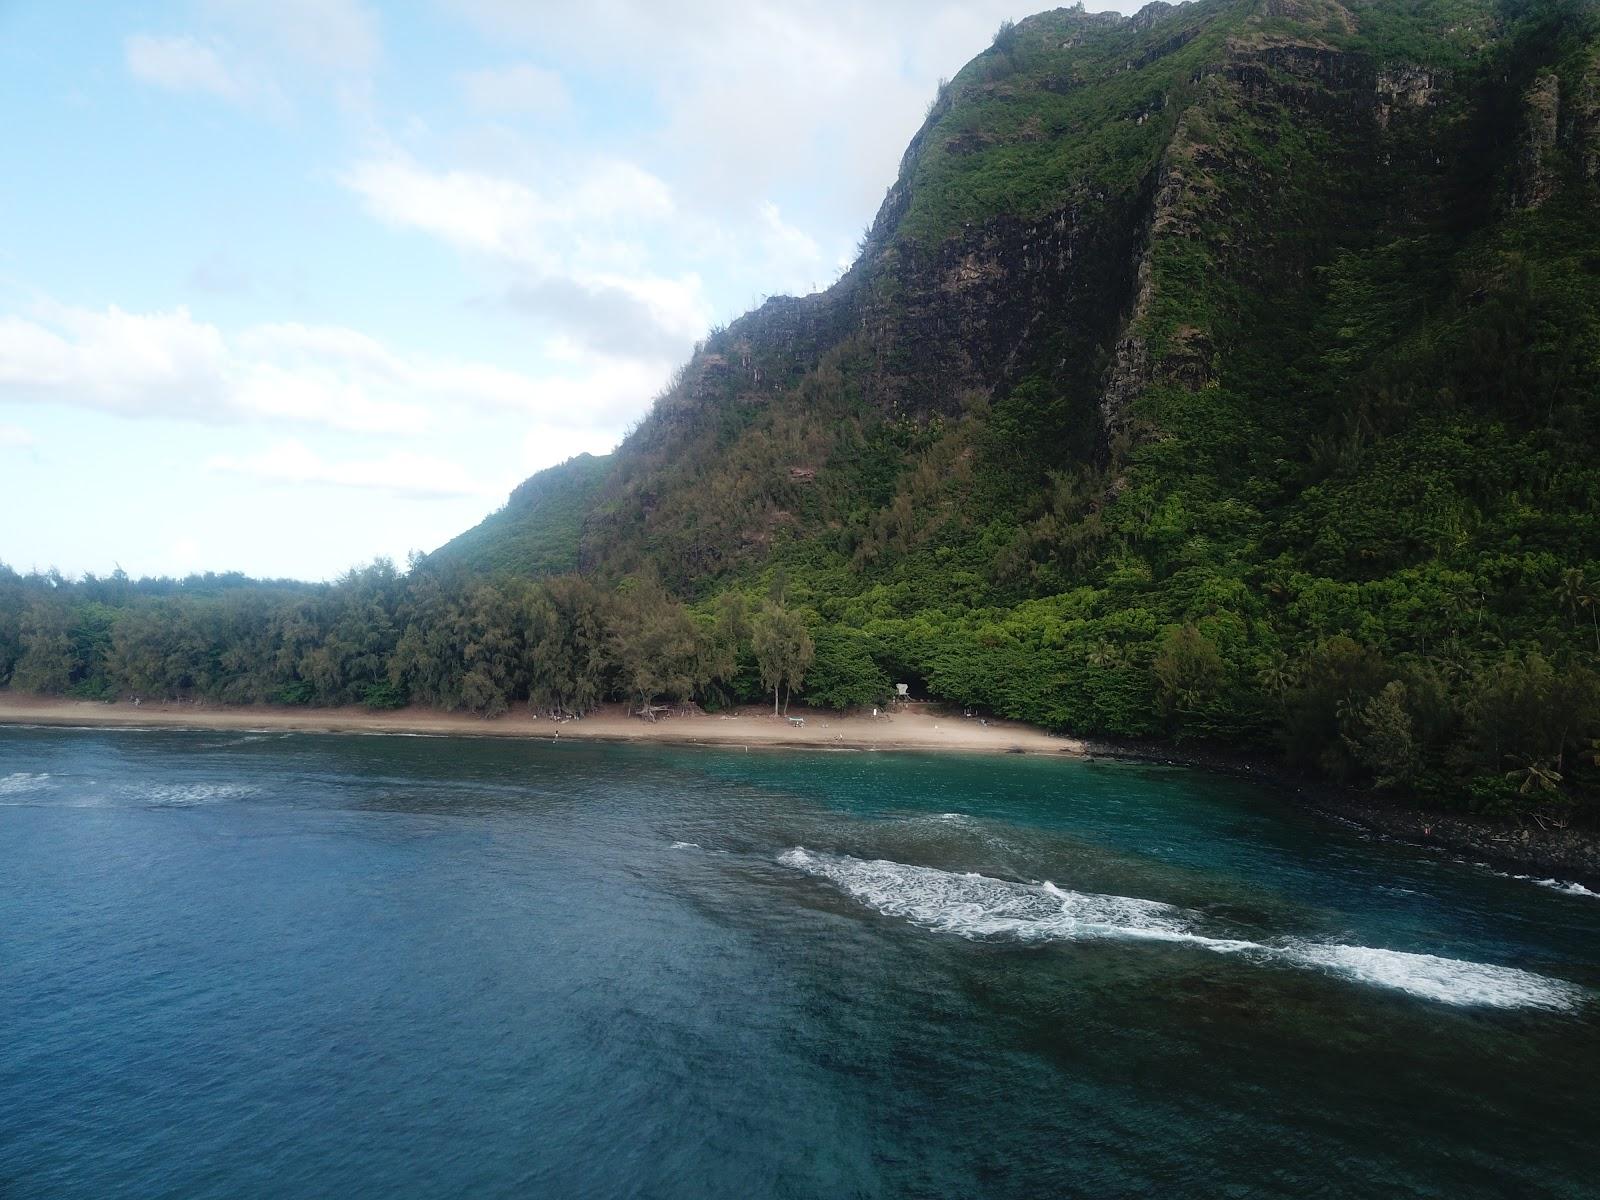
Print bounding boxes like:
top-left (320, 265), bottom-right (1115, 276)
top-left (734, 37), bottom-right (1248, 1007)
top-left (425, 0), bottom-right (1600, 812)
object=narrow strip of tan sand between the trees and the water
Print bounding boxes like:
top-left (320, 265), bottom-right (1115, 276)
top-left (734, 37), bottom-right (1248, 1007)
top-left (0, 694), bottom-right (1085, 754)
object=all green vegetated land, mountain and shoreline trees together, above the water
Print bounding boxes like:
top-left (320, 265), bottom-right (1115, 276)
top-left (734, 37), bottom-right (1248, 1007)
top-left (0, 0), bottom-right (1600, 821)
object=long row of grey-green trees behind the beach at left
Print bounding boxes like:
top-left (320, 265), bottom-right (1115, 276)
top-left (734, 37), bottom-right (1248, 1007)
top-left (0, 560), bottom-right (832, 717)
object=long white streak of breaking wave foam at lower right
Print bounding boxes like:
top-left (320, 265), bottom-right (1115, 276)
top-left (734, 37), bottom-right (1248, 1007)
top-left (778, 846), bottom-right (1584, 1010)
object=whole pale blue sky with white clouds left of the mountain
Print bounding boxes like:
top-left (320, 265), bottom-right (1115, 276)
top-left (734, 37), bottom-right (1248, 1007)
top-left (0, 0), bottom-right (1134, 579)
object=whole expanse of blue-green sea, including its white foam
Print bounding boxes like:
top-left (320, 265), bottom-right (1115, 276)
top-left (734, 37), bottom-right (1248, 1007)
top-left (0, 730), bottom-right (1600, 1200)
